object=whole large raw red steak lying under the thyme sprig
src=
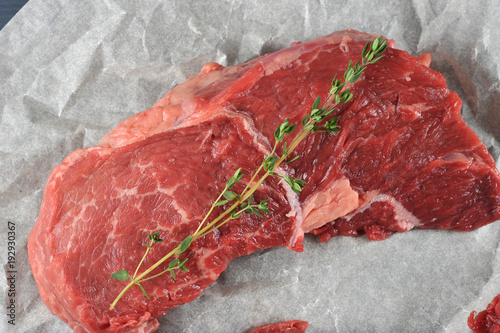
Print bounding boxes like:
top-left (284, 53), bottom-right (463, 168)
top-left (28, 30), bottom-right (500, 332)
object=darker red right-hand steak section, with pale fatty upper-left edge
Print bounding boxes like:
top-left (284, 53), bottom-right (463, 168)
top-left (100, 30), bottom-right (500, 241)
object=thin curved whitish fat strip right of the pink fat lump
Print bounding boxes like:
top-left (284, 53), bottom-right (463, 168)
top-left (344, 191), bottom-right (422, 231)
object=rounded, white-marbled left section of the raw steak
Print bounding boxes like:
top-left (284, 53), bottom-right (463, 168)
top-left (28, 113), bottom-right (303, 332)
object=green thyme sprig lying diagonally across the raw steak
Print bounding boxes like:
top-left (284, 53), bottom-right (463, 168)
top-left (110, 37), bottom-right (387, 310)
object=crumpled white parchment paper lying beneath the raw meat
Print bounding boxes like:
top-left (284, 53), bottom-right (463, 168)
top-left (0, 0), bottom-right (500, 333)
